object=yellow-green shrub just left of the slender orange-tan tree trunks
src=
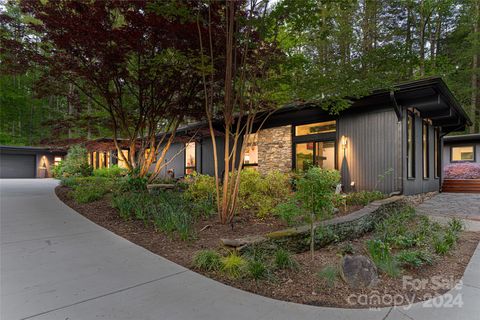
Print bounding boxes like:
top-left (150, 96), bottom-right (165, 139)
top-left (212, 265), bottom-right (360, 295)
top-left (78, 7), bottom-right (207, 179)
top-left (184, 173), bottom-right (217, 216)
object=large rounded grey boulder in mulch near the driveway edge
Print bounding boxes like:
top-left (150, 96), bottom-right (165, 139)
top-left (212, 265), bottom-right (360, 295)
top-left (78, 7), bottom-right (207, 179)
top-left (340, 255), bottom-right (378, 288)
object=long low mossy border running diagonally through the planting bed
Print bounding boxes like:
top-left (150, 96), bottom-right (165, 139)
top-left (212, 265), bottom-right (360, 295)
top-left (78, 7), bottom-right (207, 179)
top-left (220, 196), bottom-right (408, 252)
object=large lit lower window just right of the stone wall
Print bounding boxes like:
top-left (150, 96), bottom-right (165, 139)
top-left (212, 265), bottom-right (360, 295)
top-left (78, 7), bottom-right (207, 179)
top-left (295, 141), bottom-right (335, 171)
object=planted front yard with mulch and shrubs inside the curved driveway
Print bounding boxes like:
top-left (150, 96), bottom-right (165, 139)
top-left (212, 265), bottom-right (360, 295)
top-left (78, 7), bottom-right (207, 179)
top-left (56, 165), bottom-right (480, 308)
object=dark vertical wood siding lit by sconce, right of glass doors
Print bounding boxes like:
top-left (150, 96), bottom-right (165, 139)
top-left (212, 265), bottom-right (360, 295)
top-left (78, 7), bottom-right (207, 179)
top-left (337, 108), bottom-right (402, 193)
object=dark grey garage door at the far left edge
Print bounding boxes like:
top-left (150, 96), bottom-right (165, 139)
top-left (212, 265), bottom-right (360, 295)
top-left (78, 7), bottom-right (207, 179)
top-left (0, 153), bottom-right (36, 178)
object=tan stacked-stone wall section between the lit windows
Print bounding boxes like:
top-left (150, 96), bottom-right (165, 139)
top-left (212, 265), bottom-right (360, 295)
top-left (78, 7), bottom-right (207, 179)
top-left (258, 125), bottom-right (292, 174)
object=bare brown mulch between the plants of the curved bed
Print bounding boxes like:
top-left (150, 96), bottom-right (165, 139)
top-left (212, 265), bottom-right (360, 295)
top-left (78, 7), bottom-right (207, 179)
top-left (55, 186), bottom-right (480, 308)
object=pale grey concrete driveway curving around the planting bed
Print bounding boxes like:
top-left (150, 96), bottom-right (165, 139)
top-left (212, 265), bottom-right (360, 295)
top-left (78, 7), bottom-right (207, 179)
top-left (0, 179), bottom-right (480, 320)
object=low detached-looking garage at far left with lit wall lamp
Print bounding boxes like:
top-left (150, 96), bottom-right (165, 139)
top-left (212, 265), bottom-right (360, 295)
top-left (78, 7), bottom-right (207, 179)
top-left (0, 146), bottom-right (65, 179)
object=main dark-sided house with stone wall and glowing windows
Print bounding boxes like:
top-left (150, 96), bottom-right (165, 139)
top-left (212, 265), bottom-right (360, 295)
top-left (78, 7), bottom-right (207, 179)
top-left (156, 78), bottom-right (471, 195)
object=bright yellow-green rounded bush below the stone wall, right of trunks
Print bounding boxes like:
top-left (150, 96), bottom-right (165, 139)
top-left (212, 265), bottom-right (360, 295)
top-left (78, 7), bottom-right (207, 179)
top-left (238, 169), bottom-right (291, 217)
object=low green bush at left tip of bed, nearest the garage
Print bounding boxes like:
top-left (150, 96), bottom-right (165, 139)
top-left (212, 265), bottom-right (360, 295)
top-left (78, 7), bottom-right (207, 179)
top-left (72, 177), bottom-right (115, 203)
